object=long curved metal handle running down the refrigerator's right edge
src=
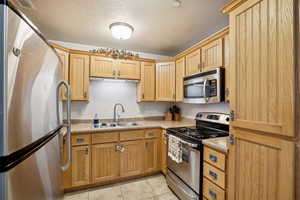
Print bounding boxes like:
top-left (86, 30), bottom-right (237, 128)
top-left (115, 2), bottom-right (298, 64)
top-left (56, 81), bottom-right (72, 171)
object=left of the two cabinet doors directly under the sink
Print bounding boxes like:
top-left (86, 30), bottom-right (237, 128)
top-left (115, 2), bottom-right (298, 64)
top-left (92, 143), bottom-right (120, 183)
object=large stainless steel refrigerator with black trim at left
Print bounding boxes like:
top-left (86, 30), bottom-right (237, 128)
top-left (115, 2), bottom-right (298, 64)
top-left (0, 1), bottom-right (71, 200)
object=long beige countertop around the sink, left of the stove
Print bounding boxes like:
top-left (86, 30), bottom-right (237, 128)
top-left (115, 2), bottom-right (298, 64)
top-left (71, 119), bottom-right (196, 134)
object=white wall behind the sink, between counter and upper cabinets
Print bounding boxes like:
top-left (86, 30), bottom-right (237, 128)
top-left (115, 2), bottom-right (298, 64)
top-left (64, 79), bottom-right (170, 119)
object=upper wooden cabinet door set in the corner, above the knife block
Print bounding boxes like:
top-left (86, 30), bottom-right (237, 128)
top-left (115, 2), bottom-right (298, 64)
top-left (156, 62), bottom-right (176, 101)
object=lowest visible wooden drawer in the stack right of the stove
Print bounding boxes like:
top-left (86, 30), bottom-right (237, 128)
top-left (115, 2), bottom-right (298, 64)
top-left (203, 178), bottom-right (225, 200)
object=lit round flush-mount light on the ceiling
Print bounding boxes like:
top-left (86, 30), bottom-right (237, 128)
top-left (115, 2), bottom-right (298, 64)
top-left (109, 22), bottom-right (133, 40)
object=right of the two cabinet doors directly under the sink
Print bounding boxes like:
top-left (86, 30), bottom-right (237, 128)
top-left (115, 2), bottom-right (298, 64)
top-left (120, 140), bottom-right (145, 177)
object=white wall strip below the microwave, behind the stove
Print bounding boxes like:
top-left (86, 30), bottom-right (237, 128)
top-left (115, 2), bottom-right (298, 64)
top-left (177, 103), bottom-right (230, 119)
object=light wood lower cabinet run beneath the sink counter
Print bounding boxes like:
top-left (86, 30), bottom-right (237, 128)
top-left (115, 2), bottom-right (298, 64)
top-left (62, 129), bottom-right (161, 190)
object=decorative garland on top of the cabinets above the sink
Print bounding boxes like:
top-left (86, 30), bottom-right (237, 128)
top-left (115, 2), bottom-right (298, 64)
top-left (89, 48), bottom-right (139, 59)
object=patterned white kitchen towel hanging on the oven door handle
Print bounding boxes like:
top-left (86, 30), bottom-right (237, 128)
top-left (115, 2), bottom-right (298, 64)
top-left (168, 135), bottom-right (182, 163)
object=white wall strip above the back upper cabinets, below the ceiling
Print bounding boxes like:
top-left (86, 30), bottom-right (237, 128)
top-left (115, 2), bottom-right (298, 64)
top-left (51, 40), bottom-right (170, 59)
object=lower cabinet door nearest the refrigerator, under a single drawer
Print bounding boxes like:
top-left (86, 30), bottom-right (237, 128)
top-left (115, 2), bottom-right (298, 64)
top-left (72, 145), bottom-right (90, 187)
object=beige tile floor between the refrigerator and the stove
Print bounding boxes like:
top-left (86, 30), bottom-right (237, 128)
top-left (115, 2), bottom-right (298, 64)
top-left (64, 175), bottom-right (178, 200)
